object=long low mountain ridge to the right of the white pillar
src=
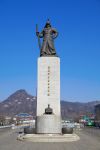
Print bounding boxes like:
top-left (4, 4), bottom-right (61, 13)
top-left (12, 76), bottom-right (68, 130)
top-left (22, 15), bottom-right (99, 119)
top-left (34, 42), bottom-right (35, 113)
top-left (61, 101), bottom-right (100, 118)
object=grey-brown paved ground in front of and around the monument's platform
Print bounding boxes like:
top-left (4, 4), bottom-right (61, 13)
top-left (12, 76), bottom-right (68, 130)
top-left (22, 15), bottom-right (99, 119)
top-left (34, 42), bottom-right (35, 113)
top-left (0, 128), bottom-right (100, 150)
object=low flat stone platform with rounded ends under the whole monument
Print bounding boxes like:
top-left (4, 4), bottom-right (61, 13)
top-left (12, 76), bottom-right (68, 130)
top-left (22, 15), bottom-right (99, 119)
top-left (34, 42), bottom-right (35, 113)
top-left (17, 134), bottom-right (80, 142)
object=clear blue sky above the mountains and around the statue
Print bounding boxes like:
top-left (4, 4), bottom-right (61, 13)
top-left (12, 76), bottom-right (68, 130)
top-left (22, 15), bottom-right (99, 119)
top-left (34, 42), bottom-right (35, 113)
top-left (0, 0), bottom-right (100, 102)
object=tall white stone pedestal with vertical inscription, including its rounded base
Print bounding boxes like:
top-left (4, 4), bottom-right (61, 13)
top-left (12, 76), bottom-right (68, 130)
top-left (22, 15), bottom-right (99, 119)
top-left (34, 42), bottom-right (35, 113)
top-left (36, 57), bottom-right (61, 134)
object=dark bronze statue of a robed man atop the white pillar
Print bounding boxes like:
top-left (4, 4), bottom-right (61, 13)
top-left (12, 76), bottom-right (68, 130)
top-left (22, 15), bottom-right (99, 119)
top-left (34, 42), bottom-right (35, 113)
top-left (36, 20), bottom-right (58, 56)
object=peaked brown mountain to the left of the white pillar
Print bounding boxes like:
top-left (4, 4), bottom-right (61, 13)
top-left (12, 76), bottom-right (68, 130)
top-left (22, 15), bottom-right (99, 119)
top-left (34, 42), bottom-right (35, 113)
top-left (0, 89), bottom-right (36, 116)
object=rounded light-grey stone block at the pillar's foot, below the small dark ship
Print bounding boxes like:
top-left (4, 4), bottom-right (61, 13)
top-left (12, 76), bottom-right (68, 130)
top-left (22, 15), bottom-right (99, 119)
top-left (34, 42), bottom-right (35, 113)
top-left (36, 114), bottom-right (61, 134)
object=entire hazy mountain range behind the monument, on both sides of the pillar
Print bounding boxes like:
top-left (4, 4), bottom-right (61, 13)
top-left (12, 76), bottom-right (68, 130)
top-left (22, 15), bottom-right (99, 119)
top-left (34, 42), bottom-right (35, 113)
top-left (0, 89), bottom-right (100, 118)
